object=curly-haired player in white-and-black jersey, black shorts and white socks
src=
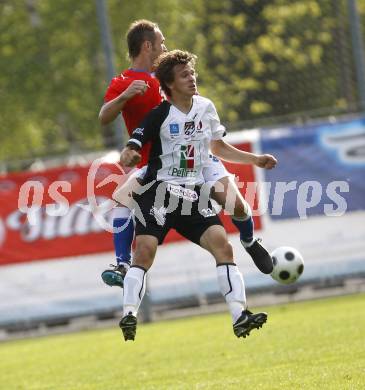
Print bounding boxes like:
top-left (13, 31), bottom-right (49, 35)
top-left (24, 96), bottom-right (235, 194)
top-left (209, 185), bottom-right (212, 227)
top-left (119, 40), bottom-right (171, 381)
top-left (117, 50), bottom-right (276, 341)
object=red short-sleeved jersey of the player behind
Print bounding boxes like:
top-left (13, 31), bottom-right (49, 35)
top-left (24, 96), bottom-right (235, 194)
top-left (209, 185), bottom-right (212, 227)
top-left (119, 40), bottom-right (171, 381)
top-left (104, 69), bottom-right (162, 167)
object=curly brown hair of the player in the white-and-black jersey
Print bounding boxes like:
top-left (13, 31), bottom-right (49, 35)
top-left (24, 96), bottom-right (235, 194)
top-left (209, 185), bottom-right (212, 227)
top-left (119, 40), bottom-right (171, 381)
top-left (155, 50), bottom-right (198, 96)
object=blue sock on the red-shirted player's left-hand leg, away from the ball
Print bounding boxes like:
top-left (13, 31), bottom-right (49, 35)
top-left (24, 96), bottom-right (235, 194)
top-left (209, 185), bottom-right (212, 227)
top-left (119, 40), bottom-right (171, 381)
top-left (113, 216), bottom-right (134, 264)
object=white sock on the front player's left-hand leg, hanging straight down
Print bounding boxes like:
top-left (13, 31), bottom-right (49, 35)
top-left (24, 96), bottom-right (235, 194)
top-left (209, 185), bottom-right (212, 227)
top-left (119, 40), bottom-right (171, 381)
top-left (123, 265), bottom-right (146, 316)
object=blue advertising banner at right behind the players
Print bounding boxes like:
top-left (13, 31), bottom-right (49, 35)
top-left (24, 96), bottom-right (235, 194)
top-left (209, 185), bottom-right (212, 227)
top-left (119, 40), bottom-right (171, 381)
top-left (261, 118), bottom-right (365, 219)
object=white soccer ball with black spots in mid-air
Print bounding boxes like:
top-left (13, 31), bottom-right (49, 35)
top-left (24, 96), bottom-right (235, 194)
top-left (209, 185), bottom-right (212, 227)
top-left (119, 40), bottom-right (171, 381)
top-left (270, 246), bottom-right (304, 284)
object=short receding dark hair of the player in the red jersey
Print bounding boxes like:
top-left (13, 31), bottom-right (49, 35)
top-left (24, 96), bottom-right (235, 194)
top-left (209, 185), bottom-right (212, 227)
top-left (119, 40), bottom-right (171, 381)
top-left (126, 19), bottom-right (159, 59)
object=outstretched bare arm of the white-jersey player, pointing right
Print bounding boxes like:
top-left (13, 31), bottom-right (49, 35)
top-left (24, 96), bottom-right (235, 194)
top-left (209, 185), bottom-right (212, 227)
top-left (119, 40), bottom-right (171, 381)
top-left (210, 140), bottom-right (277, 169)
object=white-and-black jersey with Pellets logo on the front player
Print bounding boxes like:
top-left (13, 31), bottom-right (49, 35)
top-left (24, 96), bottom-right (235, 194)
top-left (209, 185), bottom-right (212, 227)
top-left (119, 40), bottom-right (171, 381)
top-left (127, 95), bottom-right (225, 185)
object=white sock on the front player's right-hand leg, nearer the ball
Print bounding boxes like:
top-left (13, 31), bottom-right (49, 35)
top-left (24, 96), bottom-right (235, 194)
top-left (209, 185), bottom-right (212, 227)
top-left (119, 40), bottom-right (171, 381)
top-left (217, 263), bottom-right (246, 323)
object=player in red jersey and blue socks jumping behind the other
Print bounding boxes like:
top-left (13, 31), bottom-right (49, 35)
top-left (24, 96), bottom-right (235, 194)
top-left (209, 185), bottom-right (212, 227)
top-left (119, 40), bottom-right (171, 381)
top-left (99, 20), bottom-right (273, 287)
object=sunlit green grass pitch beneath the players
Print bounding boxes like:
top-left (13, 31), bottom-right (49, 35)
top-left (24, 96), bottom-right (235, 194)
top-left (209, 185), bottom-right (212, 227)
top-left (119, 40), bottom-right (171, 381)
top-left (0, 294), bottom-right (365, 390)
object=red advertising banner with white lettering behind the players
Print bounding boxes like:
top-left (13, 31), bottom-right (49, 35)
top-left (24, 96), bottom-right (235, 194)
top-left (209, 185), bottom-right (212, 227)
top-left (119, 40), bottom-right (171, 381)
top-left (0, 144), bottom-right (261, 265)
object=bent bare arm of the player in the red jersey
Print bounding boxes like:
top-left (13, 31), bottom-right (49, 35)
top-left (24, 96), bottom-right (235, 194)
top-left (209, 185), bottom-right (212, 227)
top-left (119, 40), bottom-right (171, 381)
top-left (99, 80), bottom-right (148, 125)
